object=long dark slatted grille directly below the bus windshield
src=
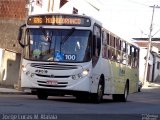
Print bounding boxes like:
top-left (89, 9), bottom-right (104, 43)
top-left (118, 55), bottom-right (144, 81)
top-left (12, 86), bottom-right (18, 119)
top-left (31, 63), bottom-right (78, 70)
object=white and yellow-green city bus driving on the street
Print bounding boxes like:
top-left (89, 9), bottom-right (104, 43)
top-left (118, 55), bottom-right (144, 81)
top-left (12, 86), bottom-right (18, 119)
top-left (18, 14), bottom-right (139, 103)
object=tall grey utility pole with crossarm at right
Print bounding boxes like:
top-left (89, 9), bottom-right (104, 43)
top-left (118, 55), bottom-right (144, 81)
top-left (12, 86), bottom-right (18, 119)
top-left (143, 5), bottom-right (160, 84)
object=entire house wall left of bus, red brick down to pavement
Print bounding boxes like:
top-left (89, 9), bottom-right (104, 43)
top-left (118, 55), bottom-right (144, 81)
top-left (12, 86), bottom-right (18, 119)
top-left (0, 0), bottom-right (27, 87)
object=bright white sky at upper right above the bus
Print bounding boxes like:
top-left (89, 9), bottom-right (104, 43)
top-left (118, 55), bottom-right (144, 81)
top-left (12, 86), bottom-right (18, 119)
top-left (97, 0), bottom-right (160, 38)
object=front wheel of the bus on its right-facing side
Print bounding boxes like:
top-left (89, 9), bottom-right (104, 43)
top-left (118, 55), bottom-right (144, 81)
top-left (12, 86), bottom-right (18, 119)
top-left (91, 80), bottom-right (104, 103)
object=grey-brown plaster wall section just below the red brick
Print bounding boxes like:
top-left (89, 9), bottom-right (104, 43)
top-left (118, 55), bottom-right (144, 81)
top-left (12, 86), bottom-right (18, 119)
top-left (0, 18), bottom-right (24, 53)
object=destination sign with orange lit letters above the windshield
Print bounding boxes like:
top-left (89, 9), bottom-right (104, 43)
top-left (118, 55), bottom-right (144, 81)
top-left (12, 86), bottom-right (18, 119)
top-left (27, 15), bottom-right (91, 27)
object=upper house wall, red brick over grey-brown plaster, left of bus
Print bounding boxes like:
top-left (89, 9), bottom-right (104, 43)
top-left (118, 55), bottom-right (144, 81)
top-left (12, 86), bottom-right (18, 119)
top-left (0, 0), bottom-right (27, 52)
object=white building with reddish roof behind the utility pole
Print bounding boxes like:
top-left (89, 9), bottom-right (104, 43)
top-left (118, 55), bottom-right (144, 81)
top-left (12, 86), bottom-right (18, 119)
top-left (133, 38), bottom-right (160, 82)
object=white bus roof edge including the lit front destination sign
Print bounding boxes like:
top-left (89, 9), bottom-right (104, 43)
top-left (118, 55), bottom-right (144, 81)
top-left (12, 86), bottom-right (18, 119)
top-left (27, 13), bottom-right (139, 48)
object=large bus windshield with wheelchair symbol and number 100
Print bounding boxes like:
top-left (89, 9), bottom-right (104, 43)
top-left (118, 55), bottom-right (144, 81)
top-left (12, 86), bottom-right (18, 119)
top-left (24, 28), bottom-right (91, 62)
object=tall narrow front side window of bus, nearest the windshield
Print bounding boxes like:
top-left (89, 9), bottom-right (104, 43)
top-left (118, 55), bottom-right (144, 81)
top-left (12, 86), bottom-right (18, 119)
top-left (93, 25), bottom-right (101, 57)
